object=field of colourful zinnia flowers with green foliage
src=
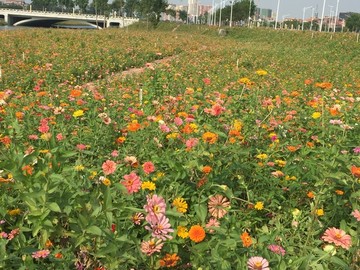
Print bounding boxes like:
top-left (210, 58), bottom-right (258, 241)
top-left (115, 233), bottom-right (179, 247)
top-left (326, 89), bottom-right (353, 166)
top-left (0, 24), bottom-right (360, 270)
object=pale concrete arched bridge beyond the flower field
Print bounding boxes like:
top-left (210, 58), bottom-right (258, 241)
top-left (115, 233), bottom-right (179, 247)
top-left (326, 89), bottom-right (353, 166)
top-left (0, 8), bottom-right (139, 28)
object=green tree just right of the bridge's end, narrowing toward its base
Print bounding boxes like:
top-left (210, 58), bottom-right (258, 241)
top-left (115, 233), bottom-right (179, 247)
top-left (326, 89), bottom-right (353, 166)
top-left (139, 0), bottom-right (169, 27)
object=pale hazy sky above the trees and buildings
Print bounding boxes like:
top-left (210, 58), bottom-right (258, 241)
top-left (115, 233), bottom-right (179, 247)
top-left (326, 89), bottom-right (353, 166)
top-left (173, 0), bottom-right (360, 20)
